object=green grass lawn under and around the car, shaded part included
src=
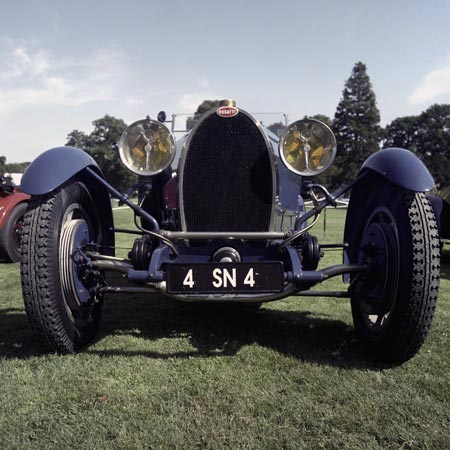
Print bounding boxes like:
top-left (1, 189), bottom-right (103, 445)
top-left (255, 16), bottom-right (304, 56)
top-left (0, 210), bottom-right (450, 449)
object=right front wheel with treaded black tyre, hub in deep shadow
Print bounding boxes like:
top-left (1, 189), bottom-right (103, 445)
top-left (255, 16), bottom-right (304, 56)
top-left (346, 179), bottom-right (440, 363)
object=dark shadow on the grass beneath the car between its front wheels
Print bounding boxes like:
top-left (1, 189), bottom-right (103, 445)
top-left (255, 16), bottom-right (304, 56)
top-left (87, 294), bottom-right (388, 370)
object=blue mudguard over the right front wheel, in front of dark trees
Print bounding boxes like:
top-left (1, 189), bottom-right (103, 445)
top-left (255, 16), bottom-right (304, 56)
top-left (361, 148), bottom-right (435, 192)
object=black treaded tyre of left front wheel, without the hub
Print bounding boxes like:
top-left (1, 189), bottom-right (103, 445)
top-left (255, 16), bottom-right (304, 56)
top-left (20, 183), bottom-right (101, 354)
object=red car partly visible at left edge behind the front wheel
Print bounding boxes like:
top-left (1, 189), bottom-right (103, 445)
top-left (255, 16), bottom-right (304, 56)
top-left (0, 177), bottom-right (30, 262)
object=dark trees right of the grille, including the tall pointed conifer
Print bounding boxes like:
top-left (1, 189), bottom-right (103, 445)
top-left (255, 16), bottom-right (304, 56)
top-left (268, 62), bottom-right (450, 189)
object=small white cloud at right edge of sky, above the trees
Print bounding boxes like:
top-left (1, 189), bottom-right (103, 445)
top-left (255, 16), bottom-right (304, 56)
top-left (408, 59), bottom-right (450, 105)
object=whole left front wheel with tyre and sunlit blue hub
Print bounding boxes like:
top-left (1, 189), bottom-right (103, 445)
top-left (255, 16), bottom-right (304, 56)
top-left (21, 182), bottom-right (102, 353)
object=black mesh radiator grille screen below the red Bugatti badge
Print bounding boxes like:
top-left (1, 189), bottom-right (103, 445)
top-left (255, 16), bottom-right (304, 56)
top-left (181, 113), bottom-right (272, 231)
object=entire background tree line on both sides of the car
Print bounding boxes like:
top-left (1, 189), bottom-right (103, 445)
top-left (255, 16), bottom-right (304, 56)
top-left (0, 62), bottom-right (450, 190)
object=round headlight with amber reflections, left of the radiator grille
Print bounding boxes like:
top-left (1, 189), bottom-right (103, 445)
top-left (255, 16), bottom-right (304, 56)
top-left (119, 118), bottom-right (175, 175)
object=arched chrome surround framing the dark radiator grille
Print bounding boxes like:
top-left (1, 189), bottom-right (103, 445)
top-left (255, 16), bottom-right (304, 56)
top-left (178, 108), bottom-right (279, 231)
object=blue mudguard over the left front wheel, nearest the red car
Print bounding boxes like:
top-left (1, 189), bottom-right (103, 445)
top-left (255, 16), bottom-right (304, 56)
top-left (21, 147), bottom-right (101, 195)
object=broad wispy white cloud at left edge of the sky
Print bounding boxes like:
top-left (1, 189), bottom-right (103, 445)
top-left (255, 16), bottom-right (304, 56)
top-left (0, 40), bottom-right (128, 113)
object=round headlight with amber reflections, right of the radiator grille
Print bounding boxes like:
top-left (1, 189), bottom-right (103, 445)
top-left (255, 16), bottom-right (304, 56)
top-left (279, 119), bottom-right (336, 176)
